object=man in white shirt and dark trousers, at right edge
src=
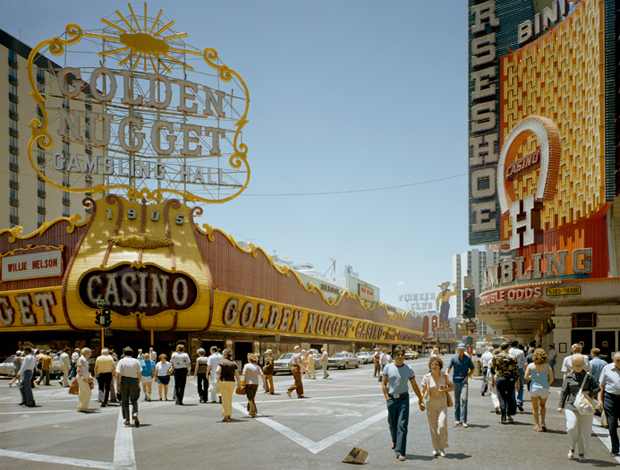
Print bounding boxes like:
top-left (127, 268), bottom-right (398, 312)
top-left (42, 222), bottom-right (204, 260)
top-left (594, 352), bottom-right (620, 457)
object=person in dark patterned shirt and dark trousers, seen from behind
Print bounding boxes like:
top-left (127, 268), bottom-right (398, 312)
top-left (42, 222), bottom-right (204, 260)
top-left (490, 343), bottom-right (520, 424)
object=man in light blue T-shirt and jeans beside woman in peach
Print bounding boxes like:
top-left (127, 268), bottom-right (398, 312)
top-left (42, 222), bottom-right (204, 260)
top-left (381, 345), bottom-right (424, 460)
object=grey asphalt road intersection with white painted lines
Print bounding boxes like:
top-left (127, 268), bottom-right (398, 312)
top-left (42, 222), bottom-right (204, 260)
top-left (0, 359), bottom-right (620, 470)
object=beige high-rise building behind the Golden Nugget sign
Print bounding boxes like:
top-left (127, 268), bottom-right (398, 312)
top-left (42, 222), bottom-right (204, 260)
top-left (0, 30), bottom-right (102, 234)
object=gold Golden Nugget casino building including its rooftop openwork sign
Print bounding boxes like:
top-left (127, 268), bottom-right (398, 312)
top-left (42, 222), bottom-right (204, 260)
top-left (0, 5), bottom-right (424, 360)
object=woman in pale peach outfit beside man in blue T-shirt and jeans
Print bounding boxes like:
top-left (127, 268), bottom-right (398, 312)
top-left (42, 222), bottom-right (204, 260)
top-left (421, 356), bottom-right (454, 457)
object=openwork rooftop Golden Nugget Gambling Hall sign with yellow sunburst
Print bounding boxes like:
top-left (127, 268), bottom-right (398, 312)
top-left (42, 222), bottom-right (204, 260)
top-left (28, 4), bottom-right (250, 203)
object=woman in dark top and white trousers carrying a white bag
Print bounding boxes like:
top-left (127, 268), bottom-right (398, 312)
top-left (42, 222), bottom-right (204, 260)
top-left (558, 354), bottom-right (601, 462)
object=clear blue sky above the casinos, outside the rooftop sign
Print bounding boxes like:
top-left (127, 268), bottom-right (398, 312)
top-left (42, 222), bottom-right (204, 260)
top-left (0, 0), bottom-right (470, 308)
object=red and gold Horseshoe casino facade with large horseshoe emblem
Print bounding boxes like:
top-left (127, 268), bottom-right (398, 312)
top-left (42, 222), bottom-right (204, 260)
top-left (468, 0), bottom-right (620, 359)
